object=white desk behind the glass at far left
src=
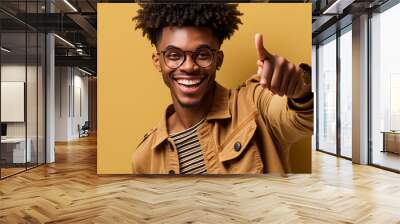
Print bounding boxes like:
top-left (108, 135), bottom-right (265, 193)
top-left (1, 138), bottom-right (32, 163)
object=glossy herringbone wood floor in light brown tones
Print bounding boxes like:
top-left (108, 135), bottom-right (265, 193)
top-left (0, 134), bottom-right (400, 224)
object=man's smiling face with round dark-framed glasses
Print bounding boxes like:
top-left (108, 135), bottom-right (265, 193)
top-left (153, 27), bottom-right (223, 108)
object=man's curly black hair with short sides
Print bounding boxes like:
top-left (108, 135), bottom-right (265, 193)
top-left (133, 3), bottom-right (243, 45)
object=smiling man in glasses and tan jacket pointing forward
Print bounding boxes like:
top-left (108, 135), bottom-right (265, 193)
top-left (132, 4), bottom-right (313, 174)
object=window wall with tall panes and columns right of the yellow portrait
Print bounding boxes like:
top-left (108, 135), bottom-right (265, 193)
top-left (313, 1), bottom-right (400, 172)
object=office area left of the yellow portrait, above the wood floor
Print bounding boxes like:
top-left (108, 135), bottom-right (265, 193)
top-left (0, 0), bottom-right (97, 179)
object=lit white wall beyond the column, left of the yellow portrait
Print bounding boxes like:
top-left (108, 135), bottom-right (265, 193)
top-left (55, 67), bottom-right (89, 141)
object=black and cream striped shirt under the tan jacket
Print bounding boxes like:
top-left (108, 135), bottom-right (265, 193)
top-left (170, 119), bottom-right (207, 174)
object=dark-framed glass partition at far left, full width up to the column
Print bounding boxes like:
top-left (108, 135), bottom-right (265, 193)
top-left (0, 1), bottom-right (46, 179)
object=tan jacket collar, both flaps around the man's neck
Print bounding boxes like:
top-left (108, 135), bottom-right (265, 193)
top-left (152, 82), bottom-right (231, 149)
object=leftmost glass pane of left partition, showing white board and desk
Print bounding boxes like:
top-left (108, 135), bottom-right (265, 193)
top-left (0, 32), bottom-right (27, 178)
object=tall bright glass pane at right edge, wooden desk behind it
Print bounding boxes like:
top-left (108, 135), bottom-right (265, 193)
top-left (370, 4), bottom-right (400, 171)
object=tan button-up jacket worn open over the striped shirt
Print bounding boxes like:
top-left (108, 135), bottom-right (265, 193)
top-left (132, 75), bottom-right (313, 174)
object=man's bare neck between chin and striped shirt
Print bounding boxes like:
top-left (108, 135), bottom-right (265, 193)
top-left (168, 84), bottom-right (215, 134)
